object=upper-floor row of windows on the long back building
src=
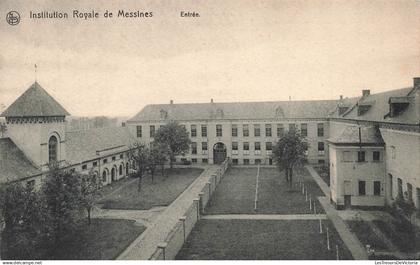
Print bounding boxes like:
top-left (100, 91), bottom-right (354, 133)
top-left (136, 123), bottom-right (324, 138)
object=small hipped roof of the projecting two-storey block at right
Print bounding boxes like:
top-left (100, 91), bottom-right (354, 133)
top-left (328, 125), bottom-right (384, 145)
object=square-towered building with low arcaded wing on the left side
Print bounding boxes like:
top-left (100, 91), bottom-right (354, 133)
top-left (0, 82), bottom-right (132, 185)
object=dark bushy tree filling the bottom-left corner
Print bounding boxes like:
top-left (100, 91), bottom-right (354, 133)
top-left (1, 183), bottom-right (48, 259)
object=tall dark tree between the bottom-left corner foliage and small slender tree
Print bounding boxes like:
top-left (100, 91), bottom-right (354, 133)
top-left (42, 166), bottom-right (82, 255)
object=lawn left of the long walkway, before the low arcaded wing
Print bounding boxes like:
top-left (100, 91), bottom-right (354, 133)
top-left (98, 168), bottom-right (203, 210)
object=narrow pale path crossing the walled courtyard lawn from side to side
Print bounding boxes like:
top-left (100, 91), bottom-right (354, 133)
top-left (201, 214), bottom-right (327, 220)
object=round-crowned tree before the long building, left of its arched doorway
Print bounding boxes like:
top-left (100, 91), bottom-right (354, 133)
top-left (154, 121), bottom-right (191, 169)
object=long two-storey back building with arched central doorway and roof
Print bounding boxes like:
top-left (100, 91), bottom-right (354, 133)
top-left (127, 100), bottom-right (337, 165)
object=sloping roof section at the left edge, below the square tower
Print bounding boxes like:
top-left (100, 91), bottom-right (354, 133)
top-left (0, 138), bottom-right (41, 183)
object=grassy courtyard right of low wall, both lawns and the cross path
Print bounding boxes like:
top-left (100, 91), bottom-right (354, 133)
top-left (176, 167), bottom-right (353, 260)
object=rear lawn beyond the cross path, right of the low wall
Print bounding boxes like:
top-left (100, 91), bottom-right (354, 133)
top-left (206, 168), bottom-right (324, 214)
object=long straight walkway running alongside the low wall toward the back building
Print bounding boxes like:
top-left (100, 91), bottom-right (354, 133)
top-left (117, 165), bottom-right (219, 260)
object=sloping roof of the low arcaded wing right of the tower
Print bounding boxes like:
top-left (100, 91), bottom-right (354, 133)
top-left (66, 127), bottom-right (135, 165)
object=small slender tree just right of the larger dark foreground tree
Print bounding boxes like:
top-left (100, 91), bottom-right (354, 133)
top-left (80, 171), bottom-right (102, 225)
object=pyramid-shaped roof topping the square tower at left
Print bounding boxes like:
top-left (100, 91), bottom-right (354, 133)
top-left (1, 82), bottom-right (70, 117)
